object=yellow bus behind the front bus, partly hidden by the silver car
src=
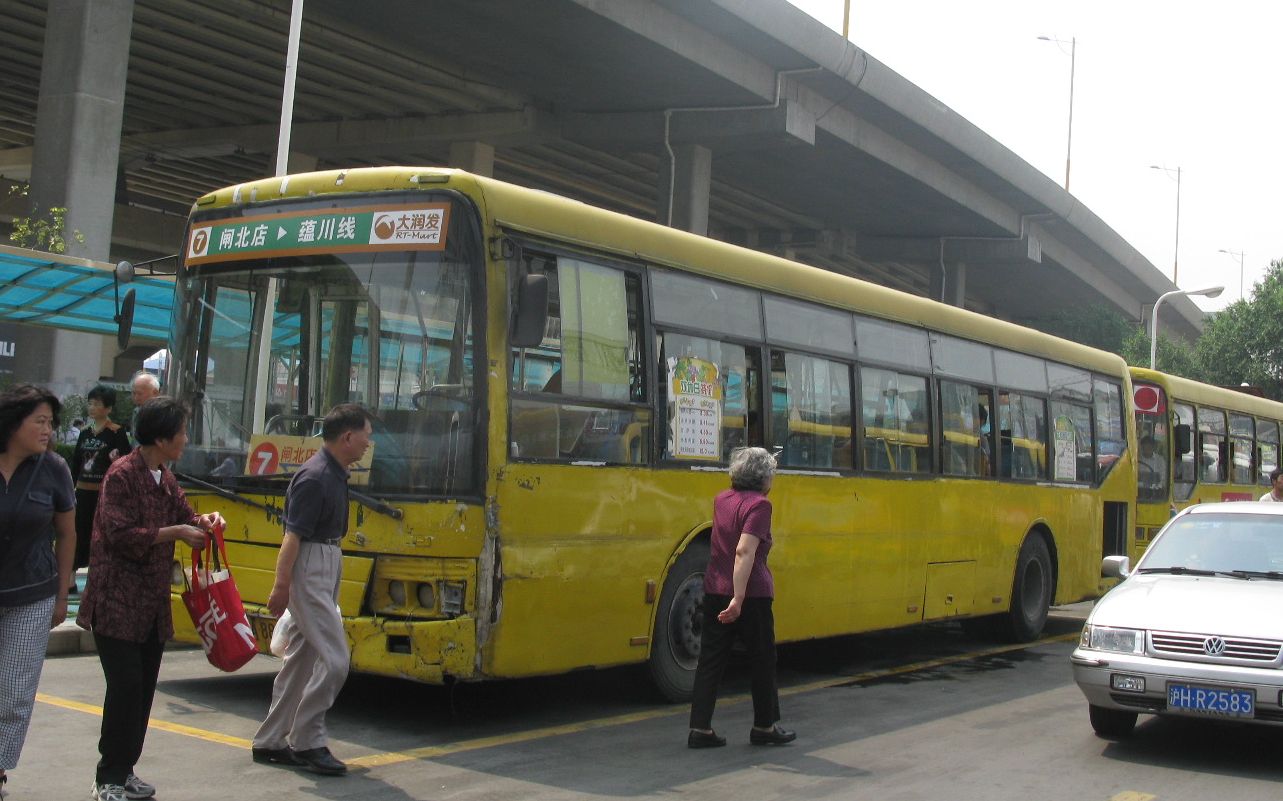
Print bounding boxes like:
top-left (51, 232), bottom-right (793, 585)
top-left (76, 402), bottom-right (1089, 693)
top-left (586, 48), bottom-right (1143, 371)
top-left (1132, 367), bottom-right (1283, 562)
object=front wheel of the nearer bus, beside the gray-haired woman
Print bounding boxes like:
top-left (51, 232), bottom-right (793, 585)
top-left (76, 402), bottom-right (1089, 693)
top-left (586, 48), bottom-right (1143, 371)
top-left (649, 539), bottom-right (708, 703)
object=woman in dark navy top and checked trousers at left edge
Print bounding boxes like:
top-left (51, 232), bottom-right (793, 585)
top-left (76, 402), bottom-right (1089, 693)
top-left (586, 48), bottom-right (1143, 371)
top-left (0, 384), bottom-right (76, 795)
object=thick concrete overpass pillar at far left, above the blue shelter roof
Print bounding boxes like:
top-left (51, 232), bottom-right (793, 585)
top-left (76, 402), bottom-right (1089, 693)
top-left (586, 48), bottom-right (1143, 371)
top-left (31, 0), bottom-right (133, 259)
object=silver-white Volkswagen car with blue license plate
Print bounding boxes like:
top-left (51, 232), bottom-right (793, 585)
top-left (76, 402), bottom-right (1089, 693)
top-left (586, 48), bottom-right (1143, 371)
top-left (1070, 502), bottom-right (1283, 737)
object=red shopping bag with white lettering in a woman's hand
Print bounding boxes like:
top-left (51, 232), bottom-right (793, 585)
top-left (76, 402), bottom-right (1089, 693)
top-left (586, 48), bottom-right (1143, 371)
top-left (182, 528), bottom-right (258, 673)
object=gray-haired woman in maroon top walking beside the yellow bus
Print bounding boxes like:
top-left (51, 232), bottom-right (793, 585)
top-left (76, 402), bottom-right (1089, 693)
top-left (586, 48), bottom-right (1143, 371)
top-left (686, 448), bottom-right (797, 748)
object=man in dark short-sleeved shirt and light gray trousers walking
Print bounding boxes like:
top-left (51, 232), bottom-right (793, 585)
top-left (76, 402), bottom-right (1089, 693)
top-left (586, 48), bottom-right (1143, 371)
top-left (251, 403), bottom-right (373, 775)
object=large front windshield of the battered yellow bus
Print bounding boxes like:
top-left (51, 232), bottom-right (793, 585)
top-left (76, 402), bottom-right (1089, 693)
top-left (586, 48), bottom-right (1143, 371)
top-left (173, 236), bottom-right (481, 495)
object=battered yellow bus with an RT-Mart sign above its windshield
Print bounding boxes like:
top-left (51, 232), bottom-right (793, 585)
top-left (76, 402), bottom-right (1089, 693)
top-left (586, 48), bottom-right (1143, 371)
top-left (169, 167), bottom-right (1135, 698)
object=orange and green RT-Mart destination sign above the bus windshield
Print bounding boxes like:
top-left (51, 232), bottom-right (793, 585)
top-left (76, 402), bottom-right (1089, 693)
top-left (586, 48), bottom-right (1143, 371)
top-left (187, 203), bottom-right (450, 264)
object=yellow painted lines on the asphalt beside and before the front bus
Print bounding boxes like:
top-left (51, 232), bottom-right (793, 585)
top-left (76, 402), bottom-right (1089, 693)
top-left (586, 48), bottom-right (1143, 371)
top-left (36, 633), bottom-right (1077, 765)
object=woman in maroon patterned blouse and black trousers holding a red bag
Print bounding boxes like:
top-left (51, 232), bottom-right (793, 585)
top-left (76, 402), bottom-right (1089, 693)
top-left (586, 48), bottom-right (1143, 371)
top-left (77, 397), bottom-right (223, 801)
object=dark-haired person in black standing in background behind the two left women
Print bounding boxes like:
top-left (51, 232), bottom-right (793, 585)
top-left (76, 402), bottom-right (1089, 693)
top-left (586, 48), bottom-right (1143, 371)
top-left (71, 384), bottom-right (132, 592)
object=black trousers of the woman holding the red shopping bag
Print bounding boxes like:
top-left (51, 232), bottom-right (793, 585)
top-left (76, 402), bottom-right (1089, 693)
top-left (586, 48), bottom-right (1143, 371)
top-left (94, 629), bottom-right (164, 784)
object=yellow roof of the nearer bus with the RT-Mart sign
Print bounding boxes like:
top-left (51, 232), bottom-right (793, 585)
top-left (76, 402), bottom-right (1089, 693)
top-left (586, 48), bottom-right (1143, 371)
top-left (192, 167), bottom-right (1126, 377)
